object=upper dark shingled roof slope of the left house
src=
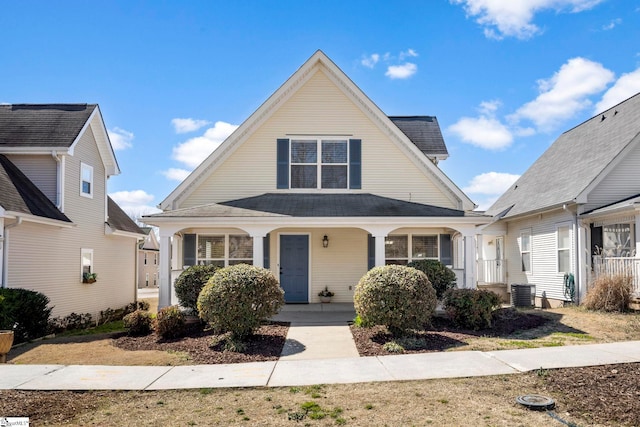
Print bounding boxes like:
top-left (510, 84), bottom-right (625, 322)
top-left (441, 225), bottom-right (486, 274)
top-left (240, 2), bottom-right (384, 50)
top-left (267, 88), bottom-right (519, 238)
top-left (0, 104), bottom-right (96, 149)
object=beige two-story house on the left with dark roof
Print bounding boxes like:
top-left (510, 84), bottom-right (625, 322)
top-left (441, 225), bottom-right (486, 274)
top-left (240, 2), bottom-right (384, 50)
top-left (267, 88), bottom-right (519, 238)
top-left (0, 104), bottom-right (144, 316)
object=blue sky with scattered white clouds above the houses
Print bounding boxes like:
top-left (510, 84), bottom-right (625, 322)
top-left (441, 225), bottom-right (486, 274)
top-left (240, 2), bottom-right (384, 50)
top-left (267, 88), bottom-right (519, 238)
top-left (0, 0), bottom-right (640, 215)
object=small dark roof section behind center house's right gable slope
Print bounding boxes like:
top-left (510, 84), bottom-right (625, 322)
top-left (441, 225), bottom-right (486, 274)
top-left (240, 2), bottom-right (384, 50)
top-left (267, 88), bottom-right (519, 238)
top-left (389, 116), bottom-right (449, 157)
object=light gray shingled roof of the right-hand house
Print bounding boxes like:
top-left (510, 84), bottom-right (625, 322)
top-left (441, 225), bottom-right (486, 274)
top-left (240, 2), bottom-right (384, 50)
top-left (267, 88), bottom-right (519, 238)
top-left (486, 93), bottom-right (640, 218)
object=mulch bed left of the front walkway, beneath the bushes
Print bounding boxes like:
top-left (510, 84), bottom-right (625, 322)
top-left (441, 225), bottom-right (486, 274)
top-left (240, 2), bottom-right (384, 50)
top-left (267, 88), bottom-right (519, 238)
top-left (113, 322), bottom-right (289, 365)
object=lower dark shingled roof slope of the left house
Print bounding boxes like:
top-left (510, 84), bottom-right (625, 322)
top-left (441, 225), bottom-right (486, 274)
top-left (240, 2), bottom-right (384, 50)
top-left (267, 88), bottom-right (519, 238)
top-left (0, 154), bottom-right (71, 222)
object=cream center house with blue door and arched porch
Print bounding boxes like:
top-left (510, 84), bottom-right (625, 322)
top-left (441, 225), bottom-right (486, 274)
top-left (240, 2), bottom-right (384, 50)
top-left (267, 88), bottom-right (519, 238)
top-left (143, 51), bottom-right (490, 307)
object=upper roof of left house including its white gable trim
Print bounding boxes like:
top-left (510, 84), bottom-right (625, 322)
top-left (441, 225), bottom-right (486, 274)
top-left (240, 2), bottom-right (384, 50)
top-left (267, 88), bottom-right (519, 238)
top-left (0, 104), bottom-right (120, 175)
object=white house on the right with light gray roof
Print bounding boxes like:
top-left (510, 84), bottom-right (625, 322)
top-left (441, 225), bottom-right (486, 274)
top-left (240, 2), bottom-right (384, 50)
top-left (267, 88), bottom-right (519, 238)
top-left (478, 94), bottom-right (640, 306)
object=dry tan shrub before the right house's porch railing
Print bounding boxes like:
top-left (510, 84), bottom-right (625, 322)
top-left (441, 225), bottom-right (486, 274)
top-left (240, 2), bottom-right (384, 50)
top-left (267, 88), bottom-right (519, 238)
top-left (584, 274), bottom-right (633, 312)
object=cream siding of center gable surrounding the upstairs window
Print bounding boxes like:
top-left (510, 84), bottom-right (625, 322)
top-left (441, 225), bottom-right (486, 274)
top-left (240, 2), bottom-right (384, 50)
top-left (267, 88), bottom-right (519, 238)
top-left (176, 67), bottom-right (458, 209)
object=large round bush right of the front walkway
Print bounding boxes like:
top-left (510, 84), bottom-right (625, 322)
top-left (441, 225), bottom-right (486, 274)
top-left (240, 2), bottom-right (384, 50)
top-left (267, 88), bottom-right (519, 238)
top-left (353, 265), bottom-right (436, 336)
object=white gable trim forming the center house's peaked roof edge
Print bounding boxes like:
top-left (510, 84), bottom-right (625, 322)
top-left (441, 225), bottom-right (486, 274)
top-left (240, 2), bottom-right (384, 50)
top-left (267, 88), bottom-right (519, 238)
top-left (159, 50), bottom-right (475, 210)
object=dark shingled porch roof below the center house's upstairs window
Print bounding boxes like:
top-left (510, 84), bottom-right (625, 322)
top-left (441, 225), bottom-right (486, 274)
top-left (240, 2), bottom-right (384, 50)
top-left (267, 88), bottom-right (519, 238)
top-left (149, 193), bottom-right (464, 218)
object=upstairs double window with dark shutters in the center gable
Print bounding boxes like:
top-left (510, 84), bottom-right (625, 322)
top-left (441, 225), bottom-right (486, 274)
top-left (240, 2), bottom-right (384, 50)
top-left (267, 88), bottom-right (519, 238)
top-left (277, 138), bottom-right (361, 189)
